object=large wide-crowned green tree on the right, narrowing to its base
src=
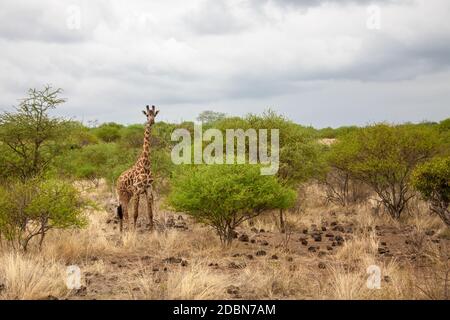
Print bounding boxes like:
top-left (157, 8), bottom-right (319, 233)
top-left (330, 124), bottom-right (439, 219)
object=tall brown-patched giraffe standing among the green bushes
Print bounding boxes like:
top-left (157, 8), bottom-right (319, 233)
top-left (117, 106), bottom-right (159, 232)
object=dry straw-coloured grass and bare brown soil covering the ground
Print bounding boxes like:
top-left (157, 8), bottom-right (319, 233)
top-left (0, 182), bottom-right (450, 300)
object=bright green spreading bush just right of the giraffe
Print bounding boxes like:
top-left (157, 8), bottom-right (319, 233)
top-left (168, 165), bottom-right (296, 244)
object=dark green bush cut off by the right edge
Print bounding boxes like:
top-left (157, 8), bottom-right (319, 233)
top-left (412, 156), bottom-right (450, 227)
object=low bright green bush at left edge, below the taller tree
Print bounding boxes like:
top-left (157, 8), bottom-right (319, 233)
top-left (0, 180), bottom-right (86, 250)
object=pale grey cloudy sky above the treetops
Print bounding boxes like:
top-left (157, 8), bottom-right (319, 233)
top-left (0, 0), bottom-right (450, 127)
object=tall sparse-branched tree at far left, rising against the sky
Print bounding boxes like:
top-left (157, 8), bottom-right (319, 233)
top-left (0, 86), bottom-right (71, 181)
